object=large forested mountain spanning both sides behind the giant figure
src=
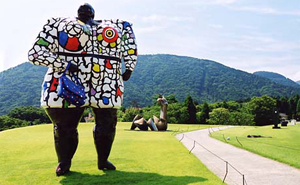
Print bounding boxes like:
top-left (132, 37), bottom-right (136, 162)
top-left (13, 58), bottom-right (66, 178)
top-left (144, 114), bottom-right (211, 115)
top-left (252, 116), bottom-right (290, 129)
top-left (0, 54), bottom-right (300, 115)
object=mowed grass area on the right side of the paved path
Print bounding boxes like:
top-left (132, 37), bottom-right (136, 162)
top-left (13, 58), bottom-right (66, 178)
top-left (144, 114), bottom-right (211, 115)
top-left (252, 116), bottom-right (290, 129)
top-left (211, 125), bottom-right (300, 168)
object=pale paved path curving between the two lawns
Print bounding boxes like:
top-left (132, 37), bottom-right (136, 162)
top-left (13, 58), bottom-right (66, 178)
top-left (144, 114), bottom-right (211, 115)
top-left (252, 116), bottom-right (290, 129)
top-left (176, 127), bottom-right (300, 185)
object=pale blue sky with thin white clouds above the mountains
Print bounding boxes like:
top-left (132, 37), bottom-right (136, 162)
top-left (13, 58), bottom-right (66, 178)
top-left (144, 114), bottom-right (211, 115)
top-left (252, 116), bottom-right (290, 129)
top-left (0, 0), bottom-right (300, 81)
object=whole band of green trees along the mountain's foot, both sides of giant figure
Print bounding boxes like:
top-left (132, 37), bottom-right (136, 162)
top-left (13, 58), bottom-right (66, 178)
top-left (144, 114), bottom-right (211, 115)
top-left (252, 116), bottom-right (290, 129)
top-left (0, 94), bottom-right (300, 131)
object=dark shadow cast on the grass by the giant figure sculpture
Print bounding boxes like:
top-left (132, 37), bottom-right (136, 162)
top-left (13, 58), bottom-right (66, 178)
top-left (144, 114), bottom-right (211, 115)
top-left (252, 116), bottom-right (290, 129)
top-left (60, 171), bottom-right (207, 185)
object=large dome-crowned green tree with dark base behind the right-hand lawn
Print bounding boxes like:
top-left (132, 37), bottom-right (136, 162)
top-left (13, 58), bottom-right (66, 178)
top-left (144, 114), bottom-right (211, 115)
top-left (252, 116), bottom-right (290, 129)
top-left (247, 95), bottom-right (276, 126)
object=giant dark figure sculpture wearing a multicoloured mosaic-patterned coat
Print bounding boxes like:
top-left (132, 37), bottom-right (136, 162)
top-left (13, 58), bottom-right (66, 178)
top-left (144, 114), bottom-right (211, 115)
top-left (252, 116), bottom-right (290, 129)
top-left (28, 3), bottom-right (137, 176)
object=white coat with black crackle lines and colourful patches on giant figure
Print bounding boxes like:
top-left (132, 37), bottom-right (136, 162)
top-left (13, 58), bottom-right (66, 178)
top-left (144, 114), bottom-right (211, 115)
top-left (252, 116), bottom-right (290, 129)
top-left (28, 18), bottom-right (137, 108)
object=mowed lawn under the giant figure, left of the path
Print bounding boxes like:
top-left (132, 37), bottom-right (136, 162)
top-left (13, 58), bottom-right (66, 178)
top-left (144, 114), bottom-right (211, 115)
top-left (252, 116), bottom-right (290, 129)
top-left (0, 123), bottom-right (222, 185)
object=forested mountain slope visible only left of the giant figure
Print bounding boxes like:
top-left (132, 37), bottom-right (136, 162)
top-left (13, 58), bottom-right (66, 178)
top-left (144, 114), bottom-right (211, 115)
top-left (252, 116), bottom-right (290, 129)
top-left (0, 62), bottom-right (47, 115)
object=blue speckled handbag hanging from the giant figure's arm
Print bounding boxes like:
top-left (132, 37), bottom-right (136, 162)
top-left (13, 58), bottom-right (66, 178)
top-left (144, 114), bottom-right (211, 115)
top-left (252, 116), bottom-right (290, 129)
top-left (57, 62), bottom-right (86, 107)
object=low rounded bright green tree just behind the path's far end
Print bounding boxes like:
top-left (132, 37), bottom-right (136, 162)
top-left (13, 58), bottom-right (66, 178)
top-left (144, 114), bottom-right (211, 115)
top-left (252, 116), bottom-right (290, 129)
top-left (208, 107), bottom-right (230, 125)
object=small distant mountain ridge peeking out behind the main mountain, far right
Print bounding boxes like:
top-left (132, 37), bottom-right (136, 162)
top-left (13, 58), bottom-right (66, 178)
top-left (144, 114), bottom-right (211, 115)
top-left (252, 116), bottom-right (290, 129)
top-left (253, 71), bottom-right (300, 88)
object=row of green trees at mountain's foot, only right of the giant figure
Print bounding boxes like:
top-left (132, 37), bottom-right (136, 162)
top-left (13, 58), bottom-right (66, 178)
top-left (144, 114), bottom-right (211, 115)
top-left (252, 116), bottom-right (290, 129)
top-left (118, 95), bottom-right (300, 126)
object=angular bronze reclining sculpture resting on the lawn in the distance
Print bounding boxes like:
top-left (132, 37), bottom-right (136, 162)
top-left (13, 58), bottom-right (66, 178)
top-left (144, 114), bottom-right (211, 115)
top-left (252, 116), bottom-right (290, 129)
top-left (130, 94), bottom-right (168, 131)
